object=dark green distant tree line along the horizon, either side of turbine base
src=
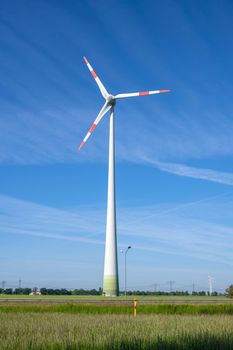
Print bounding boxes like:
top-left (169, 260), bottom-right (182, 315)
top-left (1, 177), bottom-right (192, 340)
top-left (0, 286), bottom-right (222, 296)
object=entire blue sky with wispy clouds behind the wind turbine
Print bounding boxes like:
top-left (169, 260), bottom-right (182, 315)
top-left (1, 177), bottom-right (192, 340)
top-left (0, 0), bottom-right (233, 291)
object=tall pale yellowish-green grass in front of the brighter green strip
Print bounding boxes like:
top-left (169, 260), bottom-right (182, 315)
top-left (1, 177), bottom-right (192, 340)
top-left (0, 313), bottom-right (233, 350)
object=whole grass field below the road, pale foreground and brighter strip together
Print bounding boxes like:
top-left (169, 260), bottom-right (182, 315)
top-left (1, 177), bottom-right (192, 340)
top-left (0, 299), bottom-right (233, 350)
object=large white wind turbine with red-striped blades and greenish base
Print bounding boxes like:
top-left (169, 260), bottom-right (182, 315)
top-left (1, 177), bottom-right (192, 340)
top-left (79, 56), bottom-right (170, 296)
